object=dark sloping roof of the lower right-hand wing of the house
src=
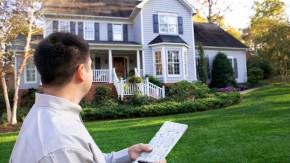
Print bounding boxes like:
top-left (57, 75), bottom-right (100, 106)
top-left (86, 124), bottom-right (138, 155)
top-left (194, 23), bottom-right (248, 48)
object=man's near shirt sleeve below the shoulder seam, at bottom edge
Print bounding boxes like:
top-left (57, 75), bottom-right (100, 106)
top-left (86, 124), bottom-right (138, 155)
top-left (38, 148), bottom-right (95, 163)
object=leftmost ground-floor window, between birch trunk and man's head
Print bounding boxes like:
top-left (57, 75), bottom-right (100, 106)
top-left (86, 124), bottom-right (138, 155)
top-left (24, 59), bottom-right (37, 83)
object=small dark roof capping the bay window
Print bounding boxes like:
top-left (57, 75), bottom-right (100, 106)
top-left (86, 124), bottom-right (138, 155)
top-left (149, 35), bottom-right (188, 45)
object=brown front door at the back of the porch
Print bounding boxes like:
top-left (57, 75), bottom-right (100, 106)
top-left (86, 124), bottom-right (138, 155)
top-left (113, 57), bottom-right (127, 79)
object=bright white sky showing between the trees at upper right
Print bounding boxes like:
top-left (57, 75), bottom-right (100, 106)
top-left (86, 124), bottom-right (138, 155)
top-left (190, 0), bottom-right (290, 29)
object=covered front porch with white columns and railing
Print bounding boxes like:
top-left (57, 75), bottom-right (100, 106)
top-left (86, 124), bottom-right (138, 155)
top-left (90, 49), bottom-right (144, 83)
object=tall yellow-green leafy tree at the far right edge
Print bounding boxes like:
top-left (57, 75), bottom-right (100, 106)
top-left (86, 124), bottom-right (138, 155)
top-left (246, 0), bottom-right (290, 80)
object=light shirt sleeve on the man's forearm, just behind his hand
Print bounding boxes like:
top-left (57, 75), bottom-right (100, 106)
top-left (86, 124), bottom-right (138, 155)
top-left (104, 148), bottom-right (132, 163)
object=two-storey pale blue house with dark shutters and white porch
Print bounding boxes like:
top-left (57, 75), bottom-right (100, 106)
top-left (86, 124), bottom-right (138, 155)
top-left (14, 0), bottom-right (246, 98)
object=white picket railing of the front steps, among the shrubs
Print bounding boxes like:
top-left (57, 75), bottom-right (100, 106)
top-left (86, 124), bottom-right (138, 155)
top-left (113, 69), bottom-right (165, 100)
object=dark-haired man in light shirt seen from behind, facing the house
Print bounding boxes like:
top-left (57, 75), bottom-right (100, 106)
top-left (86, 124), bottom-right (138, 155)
top-left (10, 32), bottom-right (165, 163)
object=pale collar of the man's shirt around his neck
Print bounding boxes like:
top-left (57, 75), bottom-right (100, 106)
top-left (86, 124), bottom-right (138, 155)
top-left (35, 93), bottom-right (82, 114)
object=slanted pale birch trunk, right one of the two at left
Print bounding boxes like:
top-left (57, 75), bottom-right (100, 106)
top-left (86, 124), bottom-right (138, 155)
top-left (11, 9), bottom-right (34, 125)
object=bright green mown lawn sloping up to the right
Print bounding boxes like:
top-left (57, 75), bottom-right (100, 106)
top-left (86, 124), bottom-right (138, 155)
top-left (0, 84), bottom-right (290, 163)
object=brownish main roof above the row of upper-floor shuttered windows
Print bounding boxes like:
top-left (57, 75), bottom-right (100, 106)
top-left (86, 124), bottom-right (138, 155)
top-left (43, 0), bottom-right (141, 18)
